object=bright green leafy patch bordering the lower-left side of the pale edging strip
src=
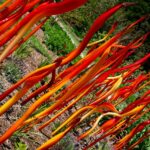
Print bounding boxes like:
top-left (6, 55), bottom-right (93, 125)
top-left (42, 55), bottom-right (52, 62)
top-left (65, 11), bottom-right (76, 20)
top-left (43, 20), bottom-right (74, 55)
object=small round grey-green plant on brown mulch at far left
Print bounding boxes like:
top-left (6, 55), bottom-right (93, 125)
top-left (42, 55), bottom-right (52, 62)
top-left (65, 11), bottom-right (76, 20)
top-left (4, 61), bottom-right (22, 83)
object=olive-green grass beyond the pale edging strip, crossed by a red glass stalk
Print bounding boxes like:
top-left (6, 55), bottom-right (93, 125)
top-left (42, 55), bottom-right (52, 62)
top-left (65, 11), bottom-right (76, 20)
top-left (62, 0), bottom-right (124, 37)
